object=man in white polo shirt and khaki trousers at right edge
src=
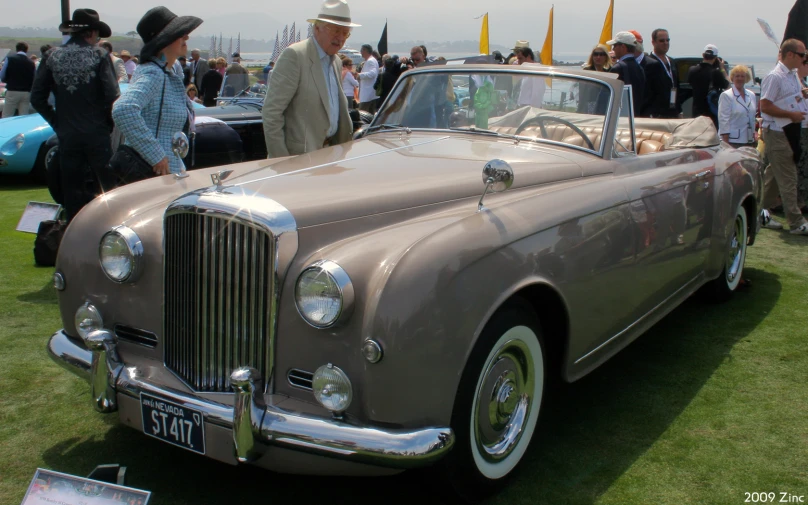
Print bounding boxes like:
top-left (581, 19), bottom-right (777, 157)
top-left (760, 39), bottom-right (808, 235)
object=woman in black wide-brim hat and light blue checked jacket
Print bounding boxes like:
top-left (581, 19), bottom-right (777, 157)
top-left (112, 7), bottom-right (202, 175)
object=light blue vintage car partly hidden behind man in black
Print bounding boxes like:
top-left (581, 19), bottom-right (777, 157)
top-left (0, 84), bottom-right (203, 183)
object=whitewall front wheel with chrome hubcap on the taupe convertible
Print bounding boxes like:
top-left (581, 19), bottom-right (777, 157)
top-left (445, 300), bottom-right (545, 501)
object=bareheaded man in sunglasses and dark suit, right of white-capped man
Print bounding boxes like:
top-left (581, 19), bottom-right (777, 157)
top-left (645, 28), bottom-right (682, 118)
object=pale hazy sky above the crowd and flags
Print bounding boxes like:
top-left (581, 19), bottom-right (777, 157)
top-left (6, 0), bottom-right (793, 59)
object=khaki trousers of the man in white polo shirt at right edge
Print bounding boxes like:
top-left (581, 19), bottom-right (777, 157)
top-left (763, 128), bottom-right (805, 230)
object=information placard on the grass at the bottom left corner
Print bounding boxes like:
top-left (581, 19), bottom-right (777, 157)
top-left (21, 468), bottom-right (151, 505)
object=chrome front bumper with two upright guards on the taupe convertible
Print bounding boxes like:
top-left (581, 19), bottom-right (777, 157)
top-left (48, 330), bottom-right (455, 469)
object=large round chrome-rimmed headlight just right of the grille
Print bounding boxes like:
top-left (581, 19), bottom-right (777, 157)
top-left (295, 261), bottom-right (354, 328)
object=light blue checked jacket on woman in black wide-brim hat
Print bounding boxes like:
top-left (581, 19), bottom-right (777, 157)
top-left (112, 59), bottom-right (192, 173)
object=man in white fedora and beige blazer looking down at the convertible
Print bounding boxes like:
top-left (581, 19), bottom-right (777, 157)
top-left (263, 0), bottom-right (361, 158)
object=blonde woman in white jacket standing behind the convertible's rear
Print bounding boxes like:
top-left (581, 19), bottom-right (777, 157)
top-left (718, 65), bottom-right (757, 148)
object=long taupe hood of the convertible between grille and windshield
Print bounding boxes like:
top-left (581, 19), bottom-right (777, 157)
top-left (108, 133), bottom-right (599, 227)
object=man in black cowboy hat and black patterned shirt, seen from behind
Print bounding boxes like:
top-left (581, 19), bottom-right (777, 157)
top-left (31, 9), bottom-right (120, 220)
